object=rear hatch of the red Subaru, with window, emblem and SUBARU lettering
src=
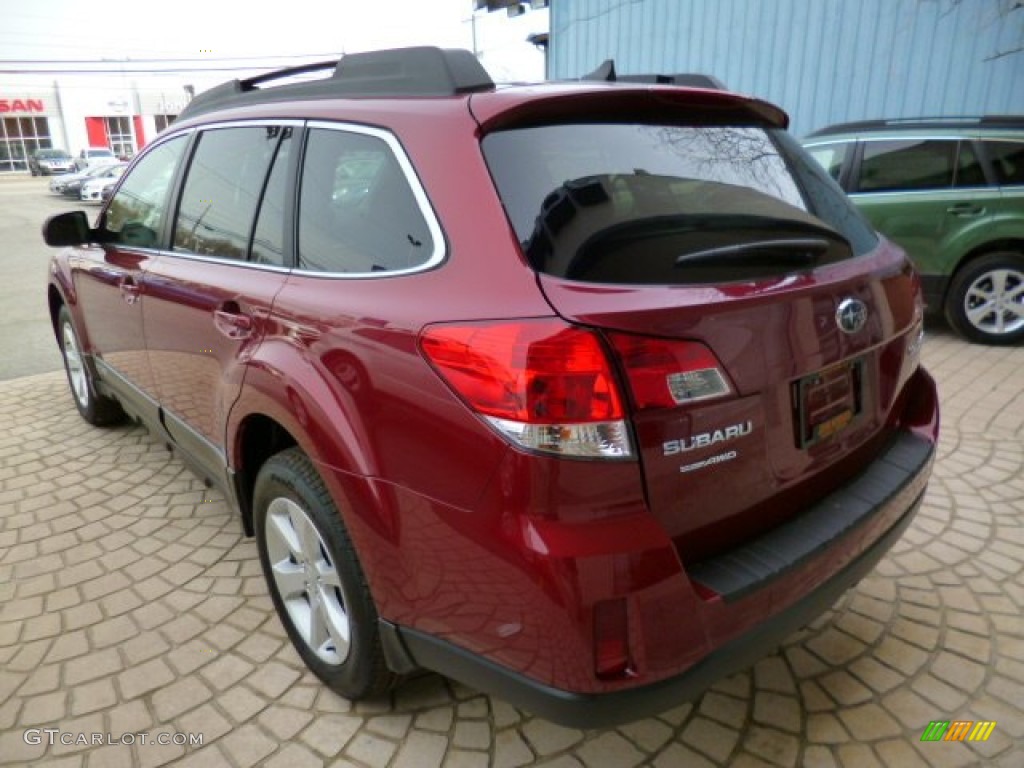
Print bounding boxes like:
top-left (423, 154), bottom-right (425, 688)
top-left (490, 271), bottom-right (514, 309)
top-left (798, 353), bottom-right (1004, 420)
top-left (482, 89), bottom-right (921, 563)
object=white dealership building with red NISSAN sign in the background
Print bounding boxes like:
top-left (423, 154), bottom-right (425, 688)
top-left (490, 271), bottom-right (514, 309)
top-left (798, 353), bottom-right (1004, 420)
top-left (0, 74), bottom-right (208, 173)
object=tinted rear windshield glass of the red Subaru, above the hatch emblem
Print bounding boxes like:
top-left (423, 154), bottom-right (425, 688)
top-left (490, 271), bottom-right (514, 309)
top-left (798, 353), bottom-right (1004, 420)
top-left (483, 124), bottom-right (877, 284)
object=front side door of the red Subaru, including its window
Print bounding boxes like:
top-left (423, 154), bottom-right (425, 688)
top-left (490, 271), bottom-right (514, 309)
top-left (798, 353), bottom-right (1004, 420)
top-left (74, 136), bottom-right (187, 421)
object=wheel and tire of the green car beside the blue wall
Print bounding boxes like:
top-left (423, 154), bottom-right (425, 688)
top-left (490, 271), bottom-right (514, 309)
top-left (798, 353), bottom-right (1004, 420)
top-left (945, 251), bottom-right (1024, 345)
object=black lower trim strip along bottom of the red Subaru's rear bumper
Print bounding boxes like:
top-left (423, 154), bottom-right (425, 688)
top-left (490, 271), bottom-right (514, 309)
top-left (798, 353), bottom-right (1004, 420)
top-left (389, 483), bottom-right (924, 728)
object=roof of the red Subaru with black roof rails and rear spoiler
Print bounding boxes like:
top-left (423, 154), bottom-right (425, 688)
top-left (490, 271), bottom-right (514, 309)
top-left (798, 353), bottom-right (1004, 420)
top-left (175, 47), bottom-right (788, 129)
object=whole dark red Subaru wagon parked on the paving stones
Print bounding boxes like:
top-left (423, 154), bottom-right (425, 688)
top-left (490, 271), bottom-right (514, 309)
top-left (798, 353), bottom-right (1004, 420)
top-left (44, 48), bottom-right (938, 727)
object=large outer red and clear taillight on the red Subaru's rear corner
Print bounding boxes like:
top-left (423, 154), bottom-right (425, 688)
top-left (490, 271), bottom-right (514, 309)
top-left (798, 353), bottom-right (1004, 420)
top-left (420, 319), bottom-right (631, 458)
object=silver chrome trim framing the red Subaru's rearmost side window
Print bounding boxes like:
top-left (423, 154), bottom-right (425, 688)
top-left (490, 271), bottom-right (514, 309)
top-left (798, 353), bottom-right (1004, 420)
top-left (291, 120), bottom-right (447, 280)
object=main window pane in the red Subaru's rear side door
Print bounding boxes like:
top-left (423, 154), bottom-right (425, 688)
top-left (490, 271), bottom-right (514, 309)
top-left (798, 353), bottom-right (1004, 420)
top-left (174, 126), bottom-right (284, 259)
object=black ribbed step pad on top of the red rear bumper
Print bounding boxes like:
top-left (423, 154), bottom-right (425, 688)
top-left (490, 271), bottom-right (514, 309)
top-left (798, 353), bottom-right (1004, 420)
top-left (686, 432), bottom-right (935, 602)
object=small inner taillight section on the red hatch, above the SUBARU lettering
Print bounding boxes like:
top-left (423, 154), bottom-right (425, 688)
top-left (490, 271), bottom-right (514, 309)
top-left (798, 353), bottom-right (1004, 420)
top-left (610, 333), bottom-right (731, 410)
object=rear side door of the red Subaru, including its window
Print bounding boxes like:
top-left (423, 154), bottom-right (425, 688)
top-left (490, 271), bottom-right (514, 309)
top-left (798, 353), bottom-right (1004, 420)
top-left (143, 123), bottom-right (294, 481)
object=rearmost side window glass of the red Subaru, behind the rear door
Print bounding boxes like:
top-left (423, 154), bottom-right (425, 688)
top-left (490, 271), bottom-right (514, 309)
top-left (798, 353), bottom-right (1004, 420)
top-left (298, 128), bottom-right (435, 274)
